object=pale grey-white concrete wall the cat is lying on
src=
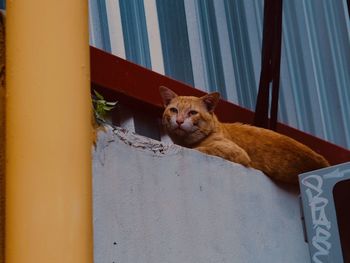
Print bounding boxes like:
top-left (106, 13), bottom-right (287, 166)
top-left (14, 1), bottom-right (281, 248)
top-left (93, 129), bottom-right (310, 263)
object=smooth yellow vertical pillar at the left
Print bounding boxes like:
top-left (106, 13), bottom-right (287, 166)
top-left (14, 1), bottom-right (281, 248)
top-left (5, 0), bottom-right (92, 263)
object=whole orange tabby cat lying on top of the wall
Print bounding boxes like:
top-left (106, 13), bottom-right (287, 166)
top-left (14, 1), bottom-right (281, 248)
top-left (160, 87), bottom-right (329, 183)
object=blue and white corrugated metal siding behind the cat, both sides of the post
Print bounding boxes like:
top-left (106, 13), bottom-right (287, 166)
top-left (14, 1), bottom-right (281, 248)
top-left (90, 0), bottom-right (350, 148)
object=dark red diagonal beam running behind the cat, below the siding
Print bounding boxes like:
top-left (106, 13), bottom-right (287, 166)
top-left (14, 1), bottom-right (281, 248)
top-left (90, 47), bottom-right (350, 165)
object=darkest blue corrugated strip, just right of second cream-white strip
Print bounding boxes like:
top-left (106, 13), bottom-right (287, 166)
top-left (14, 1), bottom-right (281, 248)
top-left (157, 0), bottom-right (194, 86)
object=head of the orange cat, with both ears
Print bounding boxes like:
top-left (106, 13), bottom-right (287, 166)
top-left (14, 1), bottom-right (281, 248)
top-left (159, 86), bottom-right (220, 147)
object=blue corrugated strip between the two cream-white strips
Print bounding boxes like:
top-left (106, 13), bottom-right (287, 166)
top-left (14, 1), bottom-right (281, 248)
top-left (119, 0), bottom-right (152, 69)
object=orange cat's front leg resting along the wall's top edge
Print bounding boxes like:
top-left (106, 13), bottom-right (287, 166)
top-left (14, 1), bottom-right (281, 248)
top-left (194, 140), bottom-right (251, 167)
